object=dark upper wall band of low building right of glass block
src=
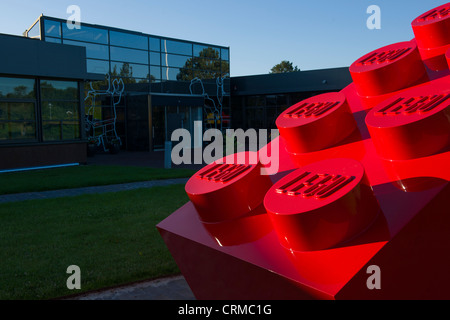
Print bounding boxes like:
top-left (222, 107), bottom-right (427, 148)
top-left (231, 67), bottom-right (352, 95)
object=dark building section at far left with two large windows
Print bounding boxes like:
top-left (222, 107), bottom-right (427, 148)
top-left (0, 34), bottom-right (89, 169)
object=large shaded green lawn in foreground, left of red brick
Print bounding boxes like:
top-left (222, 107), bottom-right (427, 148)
top-left (0, 185), bottom-right (188, 300)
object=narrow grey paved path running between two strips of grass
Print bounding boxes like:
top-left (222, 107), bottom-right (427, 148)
top-left (0, 178), bottom-right (189, 203)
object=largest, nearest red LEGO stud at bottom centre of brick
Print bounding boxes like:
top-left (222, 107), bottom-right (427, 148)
top-left (264, 158), bottom-right (379, 251)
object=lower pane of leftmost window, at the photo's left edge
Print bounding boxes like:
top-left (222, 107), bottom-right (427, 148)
top-left (0, 102), bottom-right (36, 141)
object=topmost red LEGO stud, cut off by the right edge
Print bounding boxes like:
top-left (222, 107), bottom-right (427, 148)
top-left (411, 3), bottom-right (450, 71)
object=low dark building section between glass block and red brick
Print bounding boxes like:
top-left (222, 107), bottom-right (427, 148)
top-left (231, 68), bottom-right (352, 129)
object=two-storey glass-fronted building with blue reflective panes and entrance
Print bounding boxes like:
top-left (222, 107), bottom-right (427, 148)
top-left (25, 16), bottom-right (231, 150)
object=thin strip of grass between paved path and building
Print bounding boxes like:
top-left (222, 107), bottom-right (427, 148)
top-left (0, 165), bottom-right (195, 194)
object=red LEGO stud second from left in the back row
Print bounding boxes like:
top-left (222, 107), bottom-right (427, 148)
top-left (276, 92), bottom-right (356, 153)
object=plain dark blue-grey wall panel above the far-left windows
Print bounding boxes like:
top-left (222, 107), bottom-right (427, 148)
top-left (0, 34), bottom-right (88, 80)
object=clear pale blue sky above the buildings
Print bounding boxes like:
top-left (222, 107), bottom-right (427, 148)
top-left (0, 0), bottom-right (447, 76)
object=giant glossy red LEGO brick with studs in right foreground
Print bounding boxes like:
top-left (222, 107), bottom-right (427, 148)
top-left (157, 3), bottom-right (450, 300)
